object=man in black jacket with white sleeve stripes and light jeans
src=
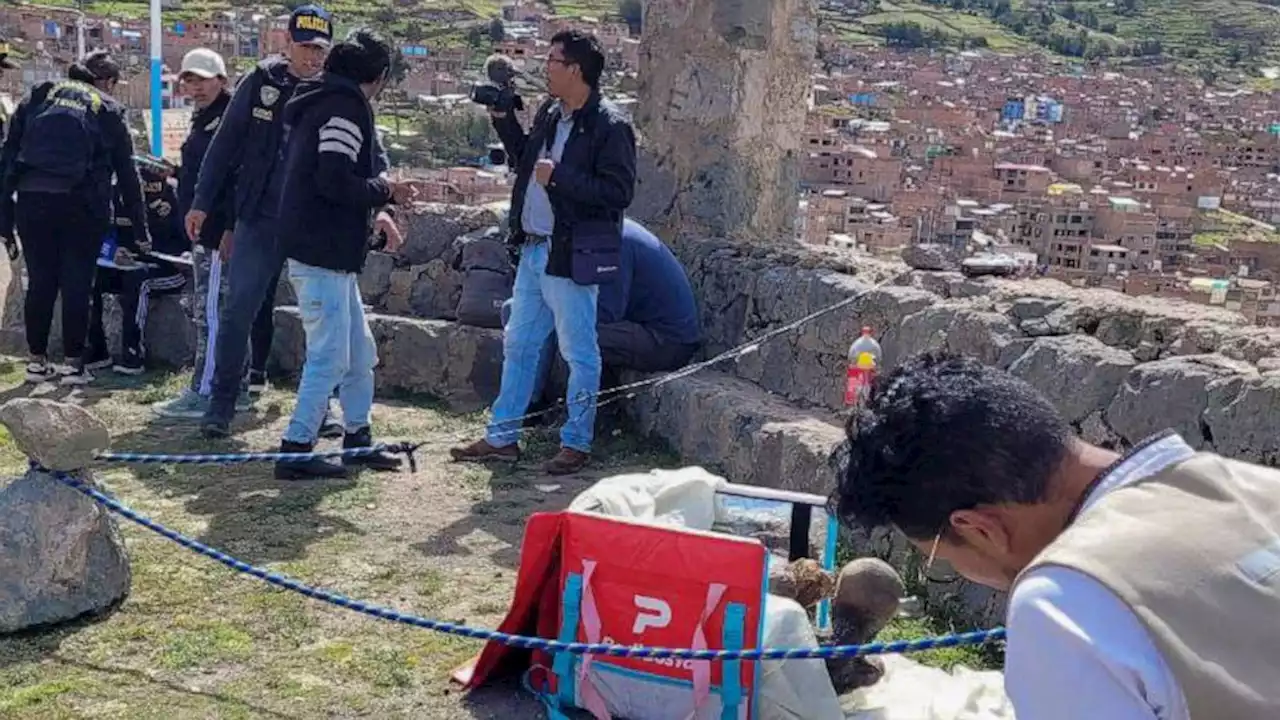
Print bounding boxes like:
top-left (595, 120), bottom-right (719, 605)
top-left (275, 31), bottom-right (415, 479)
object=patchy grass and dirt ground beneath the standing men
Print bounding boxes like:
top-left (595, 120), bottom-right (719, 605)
top-left (0, 361), bottom-right (982, 720)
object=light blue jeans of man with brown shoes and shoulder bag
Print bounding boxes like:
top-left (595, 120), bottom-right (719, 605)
top-left (485, 242), bottom-right (600, 452)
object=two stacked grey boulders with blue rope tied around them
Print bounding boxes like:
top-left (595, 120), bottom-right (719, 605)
top-left (0, 398), bottom-right (132, 634)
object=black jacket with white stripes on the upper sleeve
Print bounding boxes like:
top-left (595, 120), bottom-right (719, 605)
top-left (278, 73), bottom-right (390, 273)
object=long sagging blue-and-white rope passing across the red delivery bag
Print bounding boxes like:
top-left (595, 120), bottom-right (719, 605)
top-left (52, 464), bottom-right (1005, 660)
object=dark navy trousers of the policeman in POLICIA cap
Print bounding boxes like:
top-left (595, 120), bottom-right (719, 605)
top-left (205, 217), bottom-right (284, 423)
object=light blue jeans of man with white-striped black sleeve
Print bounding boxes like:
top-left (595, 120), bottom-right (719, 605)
top-left (284, 260), bottom-right (378, 445)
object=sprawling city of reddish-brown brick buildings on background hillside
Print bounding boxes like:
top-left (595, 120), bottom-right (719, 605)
top-left (0, 0), bottom-right (1280, 327)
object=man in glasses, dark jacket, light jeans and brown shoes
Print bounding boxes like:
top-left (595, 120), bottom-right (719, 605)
top-left (451, 31), bottom-right (636, 474)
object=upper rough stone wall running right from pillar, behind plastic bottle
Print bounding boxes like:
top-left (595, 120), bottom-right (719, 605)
top-left (677, 234), bottom-right (1280, 464)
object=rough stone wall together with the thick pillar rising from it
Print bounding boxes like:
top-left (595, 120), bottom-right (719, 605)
top-left (0, 0), bottom-right (1280, 628)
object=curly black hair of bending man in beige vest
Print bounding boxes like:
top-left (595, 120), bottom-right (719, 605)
top-left (832, 352), bottom-right (1074, 542)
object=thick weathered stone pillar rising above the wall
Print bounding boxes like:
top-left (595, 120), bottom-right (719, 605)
top-left (630, 0), bottom-right (818, 242)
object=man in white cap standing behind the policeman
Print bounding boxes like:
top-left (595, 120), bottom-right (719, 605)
top-left (152, 47), bottom-right (244, 420)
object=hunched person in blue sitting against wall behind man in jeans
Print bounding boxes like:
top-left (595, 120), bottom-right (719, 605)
top-left (502, 219), bottom-right (701, 409)
